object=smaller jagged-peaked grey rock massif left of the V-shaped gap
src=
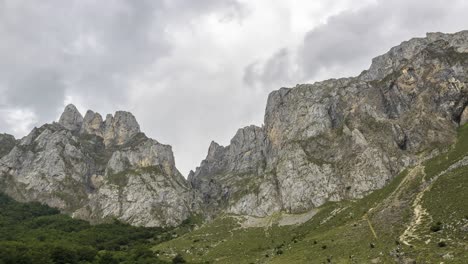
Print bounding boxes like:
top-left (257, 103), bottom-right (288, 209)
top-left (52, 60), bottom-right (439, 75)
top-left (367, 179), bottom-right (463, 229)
top-left (0, 105), bottom-right (196, 226)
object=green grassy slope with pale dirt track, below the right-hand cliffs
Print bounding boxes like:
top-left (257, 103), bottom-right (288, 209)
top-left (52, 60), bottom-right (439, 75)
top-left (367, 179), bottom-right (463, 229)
top-left (154, 125), bottom-right (468, 264)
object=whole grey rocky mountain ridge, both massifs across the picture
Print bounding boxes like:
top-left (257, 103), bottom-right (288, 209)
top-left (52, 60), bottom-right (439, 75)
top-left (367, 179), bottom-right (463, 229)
top-left (0, 31), bottom-right (468, 226)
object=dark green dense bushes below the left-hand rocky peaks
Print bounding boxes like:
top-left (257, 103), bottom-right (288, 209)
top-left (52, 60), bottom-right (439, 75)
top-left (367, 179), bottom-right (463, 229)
top-left (0, 193), bottom-right (174, 264)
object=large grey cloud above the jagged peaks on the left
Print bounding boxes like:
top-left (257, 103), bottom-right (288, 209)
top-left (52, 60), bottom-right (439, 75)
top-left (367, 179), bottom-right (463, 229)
top-left (0, 0), bottom-right (241, 128)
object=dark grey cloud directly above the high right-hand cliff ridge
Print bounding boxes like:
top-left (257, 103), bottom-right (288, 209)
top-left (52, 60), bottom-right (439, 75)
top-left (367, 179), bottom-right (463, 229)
top-left (244, 0), bottom-right (468, 86)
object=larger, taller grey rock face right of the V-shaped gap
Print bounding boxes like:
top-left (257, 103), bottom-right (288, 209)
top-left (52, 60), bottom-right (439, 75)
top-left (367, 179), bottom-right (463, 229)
top-left (189, 31), bottom-right (468, 216)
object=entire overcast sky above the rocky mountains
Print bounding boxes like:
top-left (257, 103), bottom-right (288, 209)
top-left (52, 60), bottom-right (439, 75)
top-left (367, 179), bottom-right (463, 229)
top-left (0, 0), bottom-right (468, 175)
